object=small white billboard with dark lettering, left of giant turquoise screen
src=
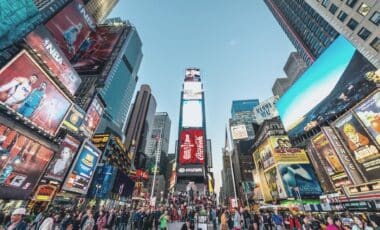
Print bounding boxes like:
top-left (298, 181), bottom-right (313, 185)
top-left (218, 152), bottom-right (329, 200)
top-left (253, 96), bottom-right (279, 124)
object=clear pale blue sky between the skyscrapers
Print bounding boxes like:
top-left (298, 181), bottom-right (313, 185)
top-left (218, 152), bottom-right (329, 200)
top-left (110, 0), bottom-right (294, 192)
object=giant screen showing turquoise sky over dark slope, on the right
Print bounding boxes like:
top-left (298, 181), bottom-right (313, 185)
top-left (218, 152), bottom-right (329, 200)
top-left (276, 36), bottom-right (376, 137)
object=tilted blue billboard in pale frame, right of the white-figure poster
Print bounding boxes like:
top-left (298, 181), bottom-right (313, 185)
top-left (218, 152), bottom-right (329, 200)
top-left (62, 140), bottom-right (101, 194)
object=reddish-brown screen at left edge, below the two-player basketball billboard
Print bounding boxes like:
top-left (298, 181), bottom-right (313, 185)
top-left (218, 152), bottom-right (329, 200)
top-left (0, 124), bottom-right (54, 200)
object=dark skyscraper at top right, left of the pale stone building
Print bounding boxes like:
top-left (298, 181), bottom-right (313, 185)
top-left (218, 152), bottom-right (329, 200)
top-left (265, 0), bottom-right (338, 65)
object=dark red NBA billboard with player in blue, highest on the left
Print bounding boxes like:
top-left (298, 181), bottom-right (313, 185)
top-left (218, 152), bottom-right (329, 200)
top-left (46, 0), bottom-right (96, 60)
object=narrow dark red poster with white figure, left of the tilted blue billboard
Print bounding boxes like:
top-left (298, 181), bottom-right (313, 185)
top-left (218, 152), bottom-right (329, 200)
top-left (45, 135), bottom-right (80, 182)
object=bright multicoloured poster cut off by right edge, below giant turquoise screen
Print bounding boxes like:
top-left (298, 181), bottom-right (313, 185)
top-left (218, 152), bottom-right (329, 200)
top-left (354, 92), bottom-right (380, 144)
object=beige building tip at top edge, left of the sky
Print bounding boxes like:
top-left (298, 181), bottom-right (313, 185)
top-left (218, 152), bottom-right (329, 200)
top-left (84, 0), bottom-right (119, 23)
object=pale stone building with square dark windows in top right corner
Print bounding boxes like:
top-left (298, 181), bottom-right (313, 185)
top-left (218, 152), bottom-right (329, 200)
top-left (306, 0), bottom-right (380, 68)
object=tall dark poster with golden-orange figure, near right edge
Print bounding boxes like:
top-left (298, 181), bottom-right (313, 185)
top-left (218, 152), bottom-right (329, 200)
top-left (335, 114), bottom-right (380, 180)
